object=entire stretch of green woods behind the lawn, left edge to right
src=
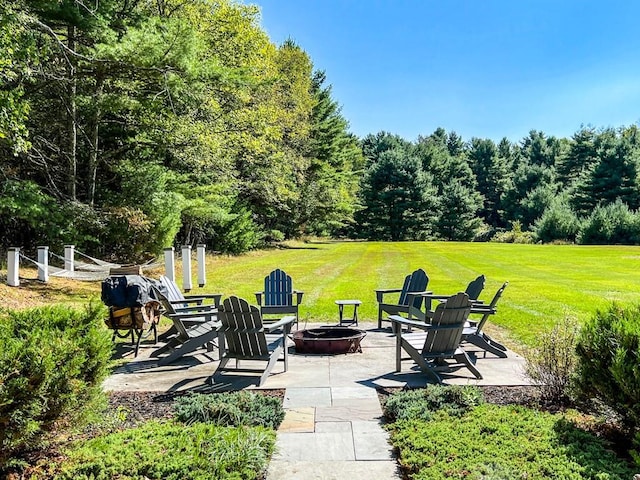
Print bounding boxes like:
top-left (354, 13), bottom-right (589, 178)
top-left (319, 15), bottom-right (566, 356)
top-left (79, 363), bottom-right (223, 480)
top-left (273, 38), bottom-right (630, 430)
top-left (0, 0), bottom-right (640, 260)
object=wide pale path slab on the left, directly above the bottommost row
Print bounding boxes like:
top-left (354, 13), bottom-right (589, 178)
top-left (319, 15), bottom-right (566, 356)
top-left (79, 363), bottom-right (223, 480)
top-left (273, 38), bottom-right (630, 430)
top-left (273, 430), bottom-right (355, 462)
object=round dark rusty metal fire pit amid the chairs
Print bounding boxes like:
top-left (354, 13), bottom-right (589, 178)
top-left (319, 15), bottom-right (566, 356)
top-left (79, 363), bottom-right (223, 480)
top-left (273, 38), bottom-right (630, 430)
top-left (293, 327), bottom-right (367, 354)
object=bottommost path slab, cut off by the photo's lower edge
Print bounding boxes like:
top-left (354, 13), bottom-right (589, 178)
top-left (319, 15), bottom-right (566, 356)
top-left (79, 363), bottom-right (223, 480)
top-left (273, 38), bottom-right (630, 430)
top-left (267, 460), bottom-right (402, 480)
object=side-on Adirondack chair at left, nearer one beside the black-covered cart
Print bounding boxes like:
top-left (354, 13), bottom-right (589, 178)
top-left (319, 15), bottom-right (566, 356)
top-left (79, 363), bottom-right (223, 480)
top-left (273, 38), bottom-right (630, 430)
top-left (151, 290), bottom-right (222, 365)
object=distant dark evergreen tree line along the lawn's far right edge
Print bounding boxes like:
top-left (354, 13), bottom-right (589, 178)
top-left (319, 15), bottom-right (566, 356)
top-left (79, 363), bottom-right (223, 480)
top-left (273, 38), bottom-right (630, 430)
top-left (355, 125), bottom-right (640, 244)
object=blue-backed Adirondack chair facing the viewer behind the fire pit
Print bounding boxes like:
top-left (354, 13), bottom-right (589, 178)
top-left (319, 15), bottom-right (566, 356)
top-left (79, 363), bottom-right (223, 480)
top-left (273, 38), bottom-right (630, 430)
top-left (256, 268), bottom-right (304, 326)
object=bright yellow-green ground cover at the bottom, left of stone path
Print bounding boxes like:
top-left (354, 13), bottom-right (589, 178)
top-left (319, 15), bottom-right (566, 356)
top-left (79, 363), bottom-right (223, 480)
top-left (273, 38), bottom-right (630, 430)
top-left (46, 421), bottom-right (275, 480)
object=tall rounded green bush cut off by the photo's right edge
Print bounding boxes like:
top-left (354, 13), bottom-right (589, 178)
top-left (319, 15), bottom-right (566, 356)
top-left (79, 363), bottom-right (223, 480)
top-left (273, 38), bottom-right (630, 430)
top-left (576, 303), bottom-right (640, 429)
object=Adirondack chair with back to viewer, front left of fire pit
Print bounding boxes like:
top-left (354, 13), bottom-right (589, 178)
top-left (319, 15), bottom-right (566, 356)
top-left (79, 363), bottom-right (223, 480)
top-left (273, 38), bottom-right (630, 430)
top-left (208, 296), bottom-right (295, 386)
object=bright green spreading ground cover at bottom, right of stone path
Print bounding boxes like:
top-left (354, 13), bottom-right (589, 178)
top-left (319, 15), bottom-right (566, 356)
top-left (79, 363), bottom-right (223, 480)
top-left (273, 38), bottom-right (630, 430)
top-left (391, 404), bottom-right (634, 480)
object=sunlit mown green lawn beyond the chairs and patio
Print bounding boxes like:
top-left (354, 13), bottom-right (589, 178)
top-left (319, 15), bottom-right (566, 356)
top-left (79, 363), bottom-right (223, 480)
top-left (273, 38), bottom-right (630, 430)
top-left (198, 242), bottom-right (640, 344)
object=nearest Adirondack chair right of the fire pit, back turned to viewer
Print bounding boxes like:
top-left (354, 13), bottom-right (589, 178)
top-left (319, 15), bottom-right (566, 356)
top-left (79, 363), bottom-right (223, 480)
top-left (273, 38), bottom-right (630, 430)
top-left (389, 292), bottom-right (482, 382)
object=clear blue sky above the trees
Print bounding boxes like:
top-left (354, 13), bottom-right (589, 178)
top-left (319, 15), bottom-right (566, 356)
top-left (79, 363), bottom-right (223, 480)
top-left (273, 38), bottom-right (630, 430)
top-left (252, 0), bottom-right (640, 141)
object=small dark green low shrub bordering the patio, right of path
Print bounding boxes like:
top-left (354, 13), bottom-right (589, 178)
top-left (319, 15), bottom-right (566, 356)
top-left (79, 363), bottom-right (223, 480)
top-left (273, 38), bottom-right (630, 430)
top-left (384, 385), bottom-right (483, 421)
